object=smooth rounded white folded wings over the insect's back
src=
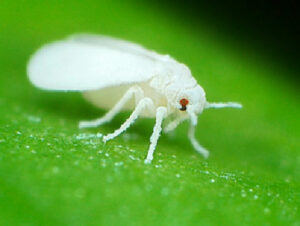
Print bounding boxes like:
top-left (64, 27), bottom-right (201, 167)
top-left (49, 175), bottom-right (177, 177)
top-left (27, 35), bottom-right (169, 91)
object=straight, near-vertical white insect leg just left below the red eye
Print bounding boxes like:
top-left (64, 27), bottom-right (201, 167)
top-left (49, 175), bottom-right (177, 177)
top-left (145, 107), bottom-right (167, 164)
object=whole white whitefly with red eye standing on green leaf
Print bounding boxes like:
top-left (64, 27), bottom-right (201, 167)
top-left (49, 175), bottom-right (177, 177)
top-left (27, 34), bottom-right (242, 163)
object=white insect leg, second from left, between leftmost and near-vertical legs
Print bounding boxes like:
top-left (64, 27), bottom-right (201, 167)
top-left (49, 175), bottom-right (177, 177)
top-left (103, 97), bottom-right (153, 142)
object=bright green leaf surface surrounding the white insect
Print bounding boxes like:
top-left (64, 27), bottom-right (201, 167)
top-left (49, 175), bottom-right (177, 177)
top-left (0, 0), bottom-right (300, 225)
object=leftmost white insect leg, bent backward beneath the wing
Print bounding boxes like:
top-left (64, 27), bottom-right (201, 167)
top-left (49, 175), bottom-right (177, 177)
top-left (79, 86), bottom-right (144, 128)
